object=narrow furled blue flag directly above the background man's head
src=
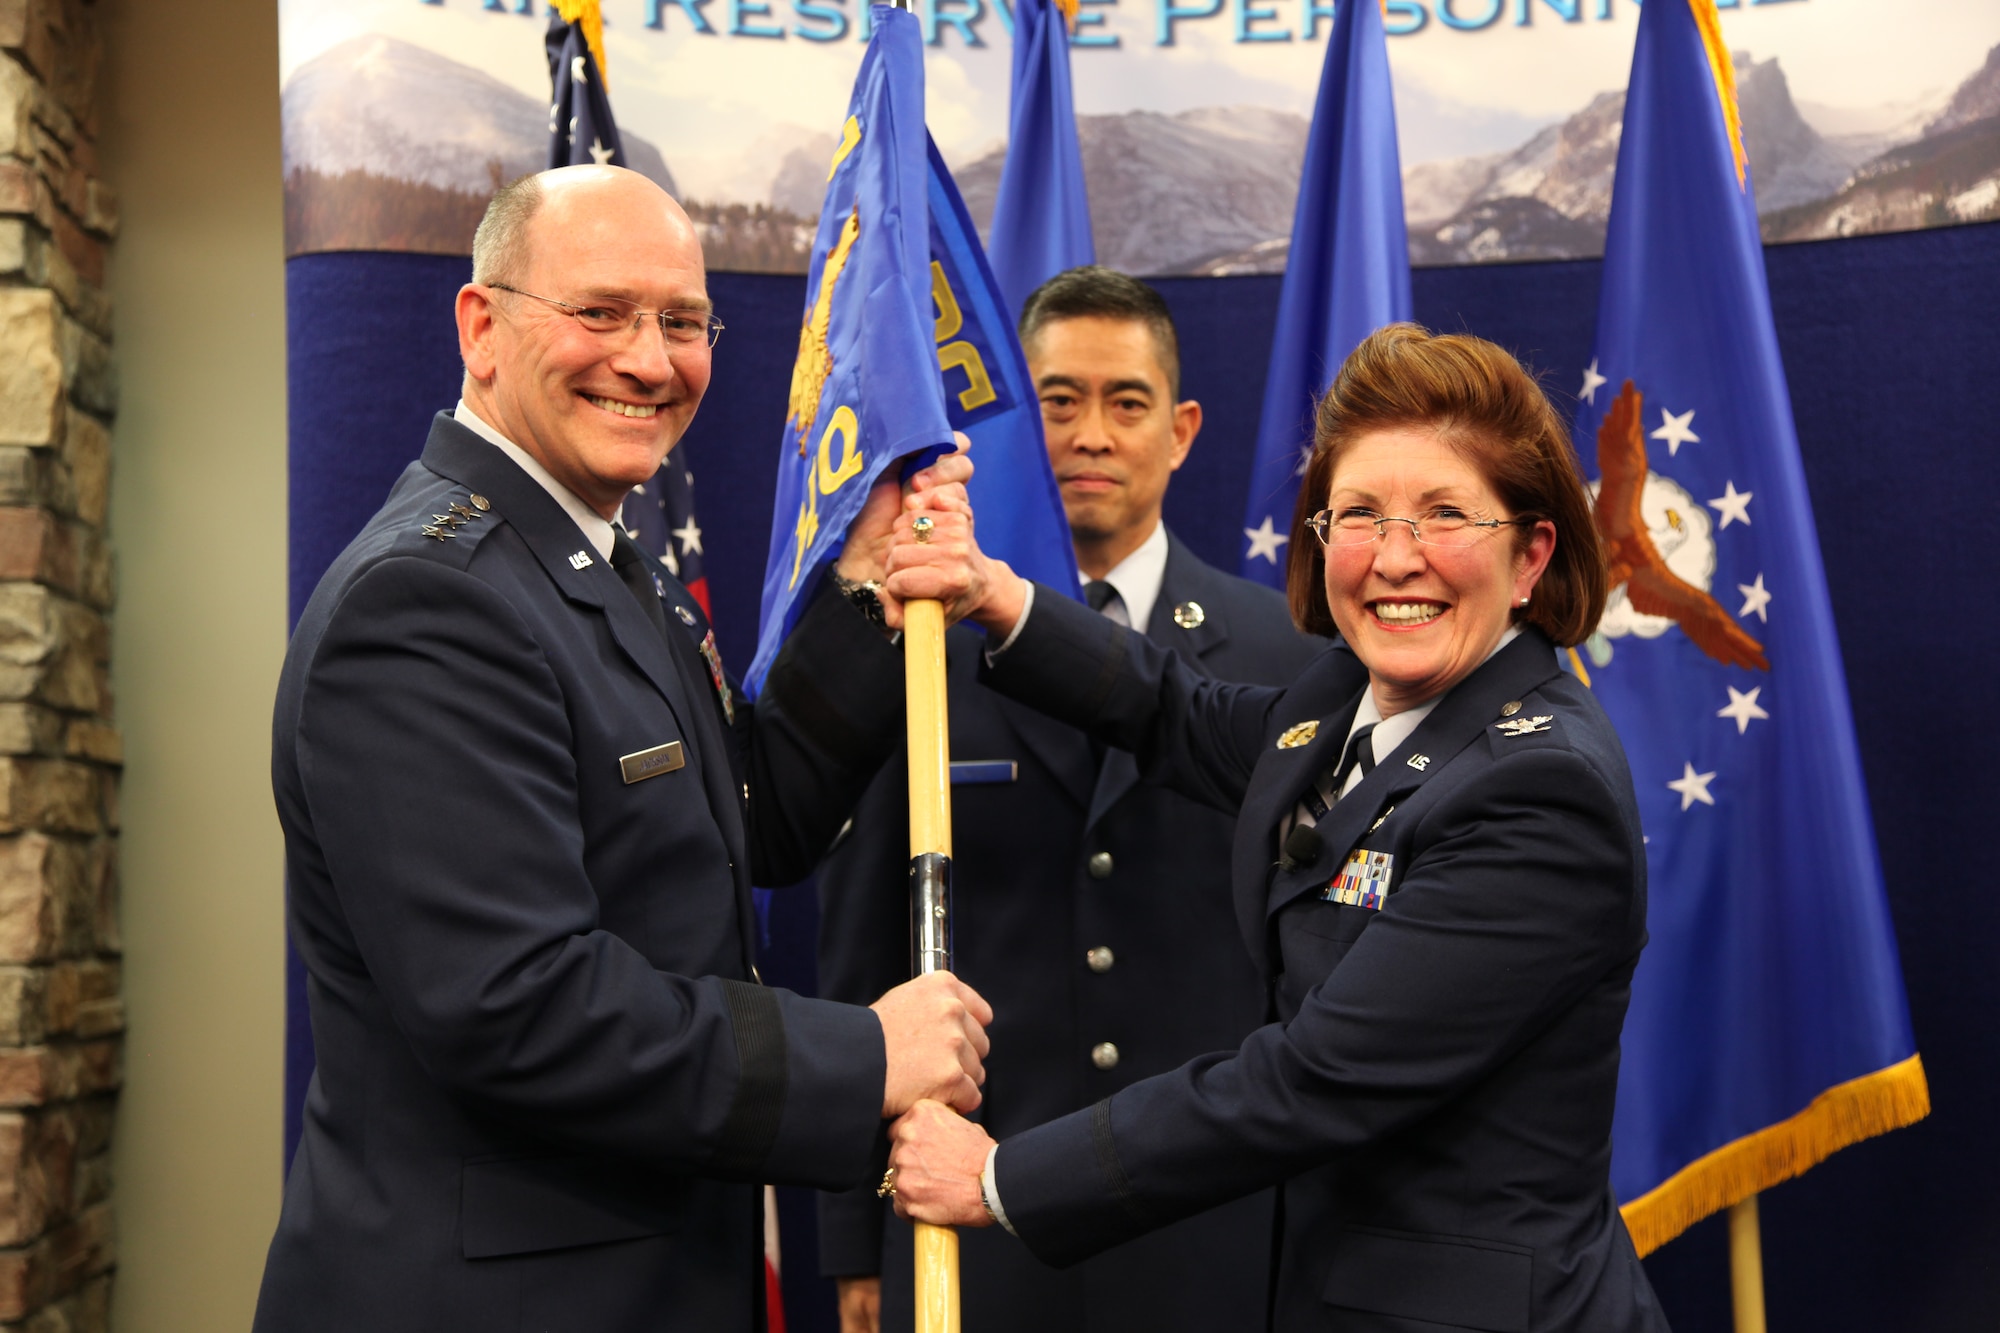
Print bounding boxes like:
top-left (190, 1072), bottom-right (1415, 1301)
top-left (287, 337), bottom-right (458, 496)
top-left (986, 0), bottom-right (1098, 318)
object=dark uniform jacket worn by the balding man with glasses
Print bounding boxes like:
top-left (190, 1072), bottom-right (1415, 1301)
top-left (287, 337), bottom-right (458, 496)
top-left (256, 416), bottom-right (902, 1333)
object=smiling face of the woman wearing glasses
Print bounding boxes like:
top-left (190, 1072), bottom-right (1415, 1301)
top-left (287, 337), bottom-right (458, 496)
top-left (1326, 428), bottom-right (1556, 717)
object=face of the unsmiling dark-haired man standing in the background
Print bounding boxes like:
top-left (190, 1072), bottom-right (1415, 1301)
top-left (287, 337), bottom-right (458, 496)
top-left (1026, 314), bottom-right (1202, 578)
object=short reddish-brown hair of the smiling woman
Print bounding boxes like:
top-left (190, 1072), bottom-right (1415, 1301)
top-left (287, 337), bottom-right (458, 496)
top-left (1286, 324), bottom-right (1606, 646)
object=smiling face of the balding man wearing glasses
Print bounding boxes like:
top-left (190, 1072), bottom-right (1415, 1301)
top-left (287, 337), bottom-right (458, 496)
top-left (458, 168), bottom-right (710, 516)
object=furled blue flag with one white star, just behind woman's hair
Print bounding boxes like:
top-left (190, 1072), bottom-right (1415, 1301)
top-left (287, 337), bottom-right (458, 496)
top-left (1242, 4), bottom-right (1410, 588)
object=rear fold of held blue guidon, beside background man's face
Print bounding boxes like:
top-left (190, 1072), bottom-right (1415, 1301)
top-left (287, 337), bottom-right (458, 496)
top-left (930, 134), bottom-right (1082, 596)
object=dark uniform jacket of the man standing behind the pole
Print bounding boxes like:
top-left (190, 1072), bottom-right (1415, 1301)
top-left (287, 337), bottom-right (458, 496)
top-left (820, 536), bottom-right (1362, 1333)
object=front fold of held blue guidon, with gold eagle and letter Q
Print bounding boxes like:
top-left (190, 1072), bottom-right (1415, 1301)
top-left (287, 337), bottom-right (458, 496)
top-left (744, 4), bottom-right (952, 697)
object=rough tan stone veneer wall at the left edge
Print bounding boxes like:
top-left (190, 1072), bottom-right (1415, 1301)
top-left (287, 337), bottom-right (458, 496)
top-left (0, 0), bottom-right (124, 1333)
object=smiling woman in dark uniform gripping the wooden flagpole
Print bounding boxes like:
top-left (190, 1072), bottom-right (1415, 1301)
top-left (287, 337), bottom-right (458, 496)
top-left (884, 324), bottom-right (1666, 1333)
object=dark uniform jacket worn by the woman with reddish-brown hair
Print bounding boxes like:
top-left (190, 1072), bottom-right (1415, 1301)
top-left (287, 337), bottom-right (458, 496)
top-left (986, 596), bottom-right (1666, 1333)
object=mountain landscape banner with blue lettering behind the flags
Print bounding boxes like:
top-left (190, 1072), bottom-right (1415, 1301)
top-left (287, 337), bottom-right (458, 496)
top-left (278, 0), bottom-right (2000, 274)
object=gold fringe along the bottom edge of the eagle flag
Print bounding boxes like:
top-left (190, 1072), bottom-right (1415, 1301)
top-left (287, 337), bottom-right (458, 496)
top-left (1620, 1055), bottom-right (1930, 1255)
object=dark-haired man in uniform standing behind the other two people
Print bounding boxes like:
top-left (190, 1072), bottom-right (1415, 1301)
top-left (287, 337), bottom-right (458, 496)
top-left (820, 266), bottom-right (1362, 1333)
